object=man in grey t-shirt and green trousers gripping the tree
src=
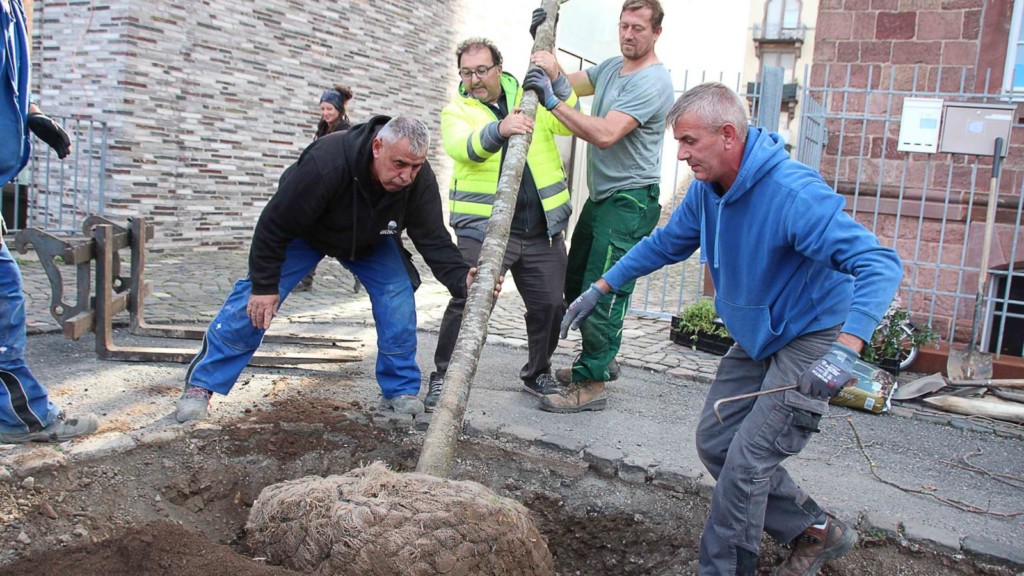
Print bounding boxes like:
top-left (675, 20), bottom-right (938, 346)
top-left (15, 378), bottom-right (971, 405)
top-left (523, 0), bottom-right (674, 412)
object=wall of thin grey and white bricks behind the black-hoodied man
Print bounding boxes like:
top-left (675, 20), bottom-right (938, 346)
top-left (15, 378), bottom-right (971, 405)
top-left (33, 0), bottom-right (532, 251)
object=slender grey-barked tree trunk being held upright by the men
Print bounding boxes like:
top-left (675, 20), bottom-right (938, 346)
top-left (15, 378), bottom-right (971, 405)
top-left (416, 0), bottom-right (559, 478)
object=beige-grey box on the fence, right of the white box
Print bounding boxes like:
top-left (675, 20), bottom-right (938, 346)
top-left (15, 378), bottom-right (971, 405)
top-left (939, 102), bottom-right (1017, 156)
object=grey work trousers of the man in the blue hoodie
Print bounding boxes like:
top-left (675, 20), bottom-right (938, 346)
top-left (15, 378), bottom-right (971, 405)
top-left (696, 327), bottom-right (839, 576)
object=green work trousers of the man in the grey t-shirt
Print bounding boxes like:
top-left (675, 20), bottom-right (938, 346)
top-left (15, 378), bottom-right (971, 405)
top-left (565, 183), bottom-right (662, 382)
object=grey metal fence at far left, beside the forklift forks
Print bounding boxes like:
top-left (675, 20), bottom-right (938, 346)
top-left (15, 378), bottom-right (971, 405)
top-left (3, 117), bottom-right (109, 233)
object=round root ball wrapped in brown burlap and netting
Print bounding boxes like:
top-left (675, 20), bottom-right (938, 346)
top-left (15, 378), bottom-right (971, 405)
top-left (246, 462), bottom-right (555, 576)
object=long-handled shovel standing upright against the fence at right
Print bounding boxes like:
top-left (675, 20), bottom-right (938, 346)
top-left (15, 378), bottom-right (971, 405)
top-left (946, 138), bottom-right (1002, 380)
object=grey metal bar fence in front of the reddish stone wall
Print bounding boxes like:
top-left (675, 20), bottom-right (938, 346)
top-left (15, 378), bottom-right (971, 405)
top-left (798, 66), bottom-right (1024, 356)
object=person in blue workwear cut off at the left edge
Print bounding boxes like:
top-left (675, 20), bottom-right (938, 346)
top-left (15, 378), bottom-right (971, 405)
top-left (0, 0), bottom-right (99, 444)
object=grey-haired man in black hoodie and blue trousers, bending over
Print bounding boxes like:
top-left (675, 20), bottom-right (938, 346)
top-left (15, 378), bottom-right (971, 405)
top-left (177, 116), bottom-right (475, 422)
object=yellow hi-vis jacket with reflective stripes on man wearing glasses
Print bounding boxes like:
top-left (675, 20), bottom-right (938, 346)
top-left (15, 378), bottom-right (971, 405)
top-left (441, 73), bottom-right (577, 240)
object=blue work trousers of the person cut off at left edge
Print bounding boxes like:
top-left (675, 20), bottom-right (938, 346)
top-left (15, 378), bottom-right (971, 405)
top-left (0, 239), bottom-right (60, 433)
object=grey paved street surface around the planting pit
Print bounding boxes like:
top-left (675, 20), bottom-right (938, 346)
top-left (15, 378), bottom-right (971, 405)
top-left (8, 247), bottom-right (1024, 565)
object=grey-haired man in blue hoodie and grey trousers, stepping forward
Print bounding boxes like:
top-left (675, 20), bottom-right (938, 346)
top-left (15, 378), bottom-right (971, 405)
top-left (562, 83), bottom-right (902, 576)
